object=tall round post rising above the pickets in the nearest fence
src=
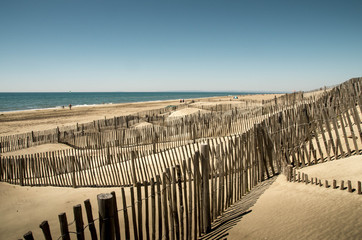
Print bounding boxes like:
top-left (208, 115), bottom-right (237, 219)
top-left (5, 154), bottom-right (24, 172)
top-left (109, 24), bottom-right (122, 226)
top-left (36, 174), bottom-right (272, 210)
top-left (201, 143), bottom-right (211, 233)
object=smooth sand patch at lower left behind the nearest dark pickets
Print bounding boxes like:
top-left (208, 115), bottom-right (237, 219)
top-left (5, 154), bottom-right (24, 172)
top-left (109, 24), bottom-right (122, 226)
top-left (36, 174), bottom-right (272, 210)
top-left (0, 183), bottom-right (130, 239)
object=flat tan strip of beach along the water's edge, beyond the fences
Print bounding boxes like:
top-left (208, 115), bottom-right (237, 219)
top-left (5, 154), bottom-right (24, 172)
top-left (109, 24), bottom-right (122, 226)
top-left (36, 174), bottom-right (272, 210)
top-left (0, 94), bottom-right (282, 136)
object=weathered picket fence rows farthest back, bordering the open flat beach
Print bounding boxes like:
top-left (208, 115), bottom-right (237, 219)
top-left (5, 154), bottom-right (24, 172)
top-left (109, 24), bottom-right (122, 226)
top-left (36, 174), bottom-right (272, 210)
top-left (0, 90), bottom-right (322, 153)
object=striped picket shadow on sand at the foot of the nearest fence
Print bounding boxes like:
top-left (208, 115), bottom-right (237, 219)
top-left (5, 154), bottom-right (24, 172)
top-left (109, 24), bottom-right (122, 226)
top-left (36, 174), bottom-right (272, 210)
top-left (199, 176), bottom-right (277, 240)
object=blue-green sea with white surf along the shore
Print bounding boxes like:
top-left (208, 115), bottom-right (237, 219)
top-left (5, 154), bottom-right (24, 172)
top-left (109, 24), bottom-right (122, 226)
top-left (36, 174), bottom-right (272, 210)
top-left (0, 92), bottom-right (262, 112)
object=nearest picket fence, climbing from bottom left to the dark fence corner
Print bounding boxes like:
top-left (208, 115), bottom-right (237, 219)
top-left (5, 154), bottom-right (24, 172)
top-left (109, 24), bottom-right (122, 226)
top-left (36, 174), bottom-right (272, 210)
top-left (19, 131), bottom-right (279, 239)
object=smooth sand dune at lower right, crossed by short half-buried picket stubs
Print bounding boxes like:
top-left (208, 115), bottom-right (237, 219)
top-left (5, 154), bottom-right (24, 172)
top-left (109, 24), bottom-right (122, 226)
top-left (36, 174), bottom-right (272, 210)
top-left (227, 156), bottom-right (362, 240)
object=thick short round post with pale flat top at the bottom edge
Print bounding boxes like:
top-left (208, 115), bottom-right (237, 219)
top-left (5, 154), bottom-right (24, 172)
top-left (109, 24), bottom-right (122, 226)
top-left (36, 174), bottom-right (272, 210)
top-left (97, 193), bottom-right (115, 240)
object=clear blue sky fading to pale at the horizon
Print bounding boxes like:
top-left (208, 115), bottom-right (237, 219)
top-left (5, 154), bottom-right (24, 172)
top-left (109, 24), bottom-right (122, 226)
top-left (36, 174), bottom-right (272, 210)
top-left (0, 0), bottom-right (362, 92)
